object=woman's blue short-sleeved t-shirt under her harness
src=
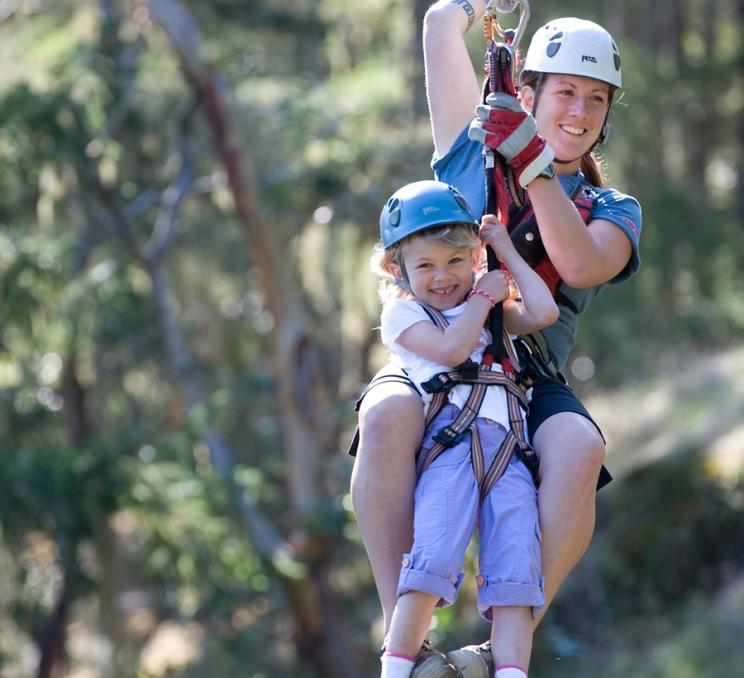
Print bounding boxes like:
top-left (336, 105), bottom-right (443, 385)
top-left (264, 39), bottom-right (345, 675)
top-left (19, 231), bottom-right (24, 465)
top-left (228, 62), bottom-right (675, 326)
top-left (432, 127), bottom-right (641, 370)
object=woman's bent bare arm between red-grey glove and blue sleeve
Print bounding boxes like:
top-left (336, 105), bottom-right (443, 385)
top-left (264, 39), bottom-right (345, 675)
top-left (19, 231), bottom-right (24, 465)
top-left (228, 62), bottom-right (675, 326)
top-left (520, 177), bottom-right (633, 288)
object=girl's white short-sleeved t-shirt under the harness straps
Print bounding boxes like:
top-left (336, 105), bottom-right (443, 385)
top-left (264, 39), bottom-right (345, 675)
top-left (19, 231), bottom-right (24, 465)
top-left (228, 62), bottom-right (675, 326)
top-left (380, 299), bottom-right (509, 429)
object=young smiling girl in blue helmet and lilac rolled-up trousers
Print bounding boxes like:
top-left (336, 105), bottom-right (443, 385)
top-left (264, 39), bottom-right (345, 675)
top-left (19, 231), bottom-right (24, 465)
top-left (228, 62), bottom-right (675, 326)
top-left (373, 181), bottom-right (558, 678)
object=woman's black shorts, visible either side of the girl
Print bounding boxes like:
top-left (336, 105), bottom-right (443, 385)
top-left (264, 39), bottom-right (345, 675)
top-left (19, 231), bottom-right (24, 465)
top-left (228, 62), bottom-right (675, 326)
top-left (349, 365), bottom-right (612, 489)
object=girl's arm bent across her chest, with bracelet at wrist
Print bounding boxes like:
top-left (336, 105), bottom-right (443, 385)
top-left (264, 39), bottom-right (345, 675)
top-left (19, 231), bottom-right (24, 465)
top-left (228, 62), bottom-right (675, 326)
top-left (396, 271), bottom-right (509, 367)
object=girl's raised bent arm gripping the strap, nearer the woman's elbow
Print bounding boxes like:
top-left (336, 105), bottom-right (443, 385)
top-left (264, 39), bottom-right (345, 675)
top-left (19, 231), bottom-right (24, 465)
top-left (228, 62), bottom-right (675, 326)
top-left (480, 214), bottom-right (559, 334)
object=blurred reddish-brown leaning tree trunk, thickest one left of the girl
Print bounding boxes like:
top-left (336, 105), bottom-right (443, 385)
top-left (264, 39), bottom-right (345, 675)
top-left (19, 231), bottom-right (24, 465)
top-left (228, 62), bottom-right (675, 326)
top-left (140, 0), bottom-right (361, 678)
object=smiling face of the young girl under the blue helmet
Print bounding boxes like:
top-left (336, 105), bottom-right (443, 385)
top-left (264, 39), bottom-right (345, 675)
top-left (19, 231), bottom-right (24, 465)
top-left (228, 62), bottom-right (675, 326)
top-left (394, 238), bottom-right (478, 311)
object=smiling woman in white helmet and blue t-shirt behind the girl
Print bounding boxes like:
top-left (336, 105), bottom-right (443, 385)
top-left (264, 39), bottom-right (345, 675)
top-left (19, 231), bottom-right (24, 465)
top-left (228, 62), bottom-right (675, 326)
top-left (351, 0), bottom-right (641, 675)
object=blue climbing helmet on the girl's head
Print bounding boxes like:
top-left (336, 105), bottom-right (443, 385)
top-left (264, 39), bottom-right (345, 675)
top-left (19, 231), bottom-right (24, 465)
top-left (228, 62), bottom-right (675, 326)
top-left (380, 181), bottom-right (478, 249)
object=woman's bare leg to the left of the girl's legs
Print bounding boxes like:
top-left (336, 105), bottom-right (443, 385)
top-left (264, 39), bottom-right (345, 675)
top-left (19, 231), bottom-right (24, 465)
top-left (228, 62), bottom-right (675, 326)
top-left (351, 384), bottom-right (424, 634)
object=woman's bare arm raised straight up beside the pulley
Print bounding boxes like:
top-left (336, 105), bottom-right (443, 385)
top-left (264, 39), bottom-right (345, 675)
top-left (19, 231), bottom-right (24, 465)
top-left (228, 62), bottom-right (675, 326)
top-left (424, 0), bottom-right (485, 157)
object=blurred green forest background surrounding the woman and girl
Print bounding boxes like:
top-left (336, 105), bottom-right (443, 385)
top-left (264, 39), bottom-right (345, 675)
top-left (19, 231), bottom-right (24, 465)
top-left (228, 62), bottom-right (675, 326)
top-left (0, 0), bottom-right (744, 678)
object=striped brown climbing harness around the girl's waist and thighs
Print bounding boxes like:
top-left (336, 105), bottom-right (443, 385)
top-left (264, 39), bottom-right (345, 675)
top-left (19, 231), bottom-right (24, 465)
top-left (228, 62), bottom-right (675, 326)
top-left (420, 304), bottom-right (539, 502)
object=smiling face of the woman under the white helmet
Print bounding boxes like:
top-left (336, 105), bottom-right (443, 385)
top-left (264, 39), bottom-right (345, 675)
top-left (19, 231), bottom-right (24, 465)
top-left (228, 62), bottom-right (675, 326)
top-left (521, 73), bottom-right (610, 174)
